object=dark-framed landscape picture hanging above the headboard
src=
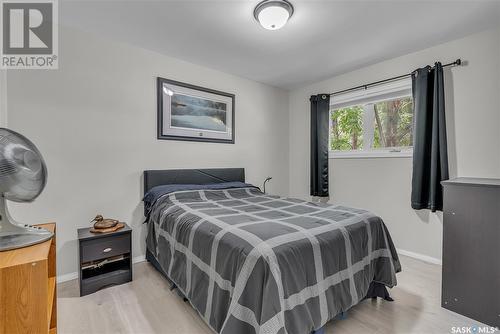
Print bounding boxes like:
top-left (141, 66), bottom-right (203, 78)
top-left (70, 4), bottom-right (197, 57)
top-left (157, 78), bottom-right (234, 144)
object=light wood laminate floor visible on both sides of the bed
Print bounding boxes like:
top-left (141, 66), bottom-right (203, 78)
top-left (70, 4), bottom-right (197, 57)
top-left (58, 256), bottom-right (480, 334)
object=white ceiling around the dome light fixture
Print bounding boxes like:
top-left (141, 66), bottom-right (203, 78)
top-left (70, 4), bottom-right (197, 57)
top-left (59, 0), bottom-right (500, 89)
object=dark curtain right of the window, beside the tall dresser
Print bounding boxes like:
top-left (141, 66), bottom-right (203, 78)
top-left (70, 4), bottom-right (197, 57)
top-left (411, 63), bottom-right (448, 212)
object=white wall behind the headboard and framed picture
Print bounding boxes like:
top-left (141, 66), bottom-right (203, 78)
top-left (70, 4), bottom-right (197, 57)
top-left (8, 29), bottom-right (289, 274)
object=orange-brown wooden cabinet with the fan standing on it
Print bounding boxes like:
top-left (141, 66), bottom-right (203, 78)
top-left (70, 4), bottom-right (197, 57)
top-left (0, 223), bottom-right (57, 334)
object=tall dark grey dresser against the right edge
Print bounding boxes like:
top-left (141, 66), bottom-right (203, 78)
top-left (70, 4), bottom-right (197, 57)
top-left (441, 178), bottom-right (500, 327)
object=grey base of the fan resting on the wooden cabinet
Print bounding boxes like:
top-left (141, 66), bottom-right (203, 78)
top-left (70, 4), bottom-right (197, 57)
top-left (0, 222), bottom-right (54, 252)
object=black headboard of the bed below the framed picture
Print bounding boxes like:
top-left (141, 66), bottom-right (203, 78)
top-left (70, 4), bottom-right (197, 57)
top-left (144, 168), bottom-right (245, 194)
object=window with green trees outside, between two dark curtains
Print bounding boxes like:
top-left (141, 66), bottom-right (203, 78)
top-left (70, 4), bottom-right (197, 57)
top-left (330, 80), bottom-right (413, 158)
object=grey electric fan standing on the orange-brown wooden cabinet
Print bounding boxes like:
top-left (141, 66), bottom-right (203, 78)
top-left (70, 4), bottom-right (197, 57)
top-left (0, 128), bottom-right (53, 251)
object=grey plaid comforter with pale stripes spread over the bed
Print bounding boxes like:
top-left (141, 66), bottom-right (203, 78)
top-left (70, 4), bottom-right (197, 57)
top-left (147, 187), bottom-right (400, 334)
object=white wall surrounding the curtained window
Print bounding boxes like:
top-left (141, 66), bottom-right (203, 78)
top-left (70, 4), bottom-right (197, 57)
top-left (289, 29), bottom-right (500, 259)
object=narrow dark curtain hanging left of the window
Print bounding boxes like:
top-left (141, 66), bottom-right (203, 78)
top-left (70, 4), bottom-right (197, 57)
top-left (309, 94), bottom-right (330, 197)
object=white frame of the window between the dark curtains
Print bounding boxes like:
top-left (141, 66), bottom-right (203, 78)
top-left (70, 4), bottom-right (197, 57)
top-left (328, 78), bottom-right (413, 159)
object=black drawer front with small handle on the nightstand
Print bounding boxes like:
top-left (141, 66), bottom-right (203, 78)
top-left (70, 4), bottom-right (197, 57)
top-left (80, 233), bottom-right (130, 262)
